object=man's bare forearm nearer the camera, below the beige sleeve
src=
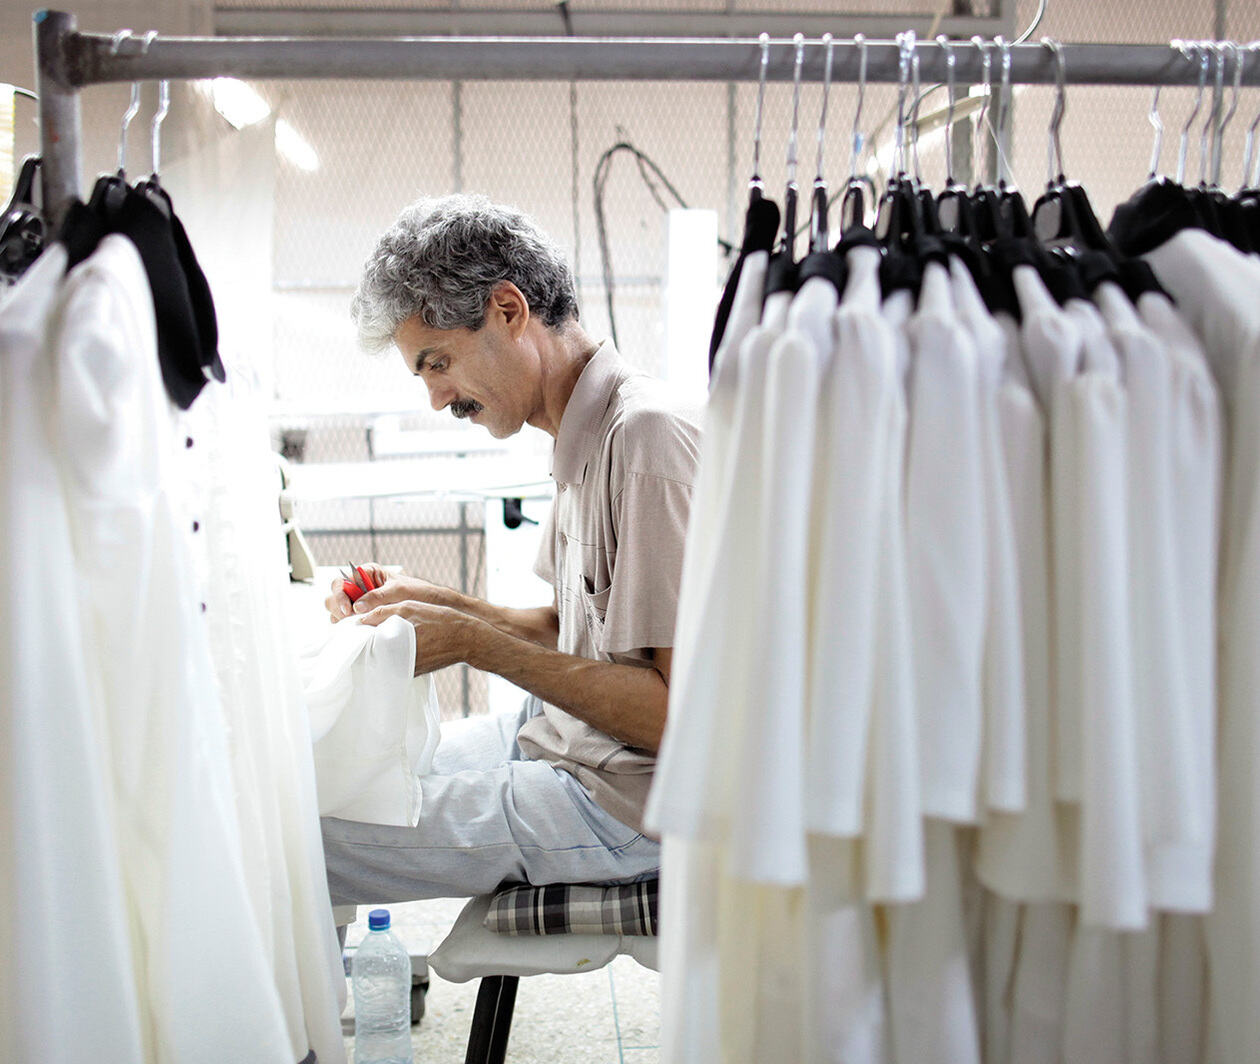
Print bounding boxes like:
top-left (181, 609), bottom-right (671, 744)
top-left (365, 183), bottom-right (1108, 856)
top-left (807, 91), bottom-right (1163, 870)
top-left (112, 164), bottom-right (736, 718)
top-left (465, 611), bottom-right (669, 753)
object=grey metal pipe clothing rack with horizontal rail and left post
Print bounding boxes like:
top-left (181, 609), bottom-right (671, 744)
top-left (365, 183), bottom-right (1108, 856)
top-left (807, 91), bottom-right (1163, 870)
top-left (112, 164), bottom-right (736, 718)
top-left (34, 10), bottom-right (1260, 222)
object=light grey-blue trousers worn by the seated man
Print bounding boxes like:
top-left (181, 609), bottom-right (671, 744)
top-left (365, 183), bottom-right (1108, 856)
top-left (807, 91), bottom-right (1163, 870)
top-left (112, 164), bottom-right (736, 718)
top-left (321, 697), bottom-right (660, 905)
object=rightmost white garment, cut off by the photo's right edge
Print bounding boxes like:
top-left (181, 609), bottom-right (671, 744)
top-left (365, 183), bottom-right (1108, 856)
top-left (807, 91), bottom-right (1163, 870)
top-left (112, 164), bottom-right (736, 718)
top-left (1147, 229), bottom-right (1260, 1064)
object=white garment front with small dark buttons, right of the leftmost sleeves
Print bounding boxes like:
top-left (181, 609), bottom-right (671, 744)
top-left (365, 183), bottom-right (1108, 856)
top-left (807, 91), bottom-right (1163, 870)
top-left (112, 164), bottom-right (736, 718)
top-left (176, 352), bottom-right (345, 1061)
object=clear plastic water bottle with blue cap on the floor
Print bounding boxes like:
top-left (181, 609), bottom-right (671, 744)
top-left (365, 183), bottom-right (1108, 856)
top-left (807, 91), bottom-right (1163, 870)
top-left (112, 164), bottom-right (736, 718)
top-left (350, 909), bottom-right (412, 1064)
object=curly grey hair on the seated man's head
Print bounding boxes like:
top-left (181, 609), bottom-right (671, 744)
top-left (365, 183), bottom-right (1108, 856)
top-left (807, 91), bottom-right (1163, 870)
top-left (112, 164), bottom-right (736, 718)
top-left (350, 195), bottom-right (577, 352)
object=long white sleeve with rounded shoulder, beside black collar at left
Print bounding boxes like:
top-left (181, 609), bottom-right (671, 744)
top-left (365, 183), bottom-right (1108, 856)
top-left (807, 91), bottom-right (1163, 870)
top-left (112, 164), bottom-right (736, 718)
top-left (49, 237), bottom-right (292, 1064)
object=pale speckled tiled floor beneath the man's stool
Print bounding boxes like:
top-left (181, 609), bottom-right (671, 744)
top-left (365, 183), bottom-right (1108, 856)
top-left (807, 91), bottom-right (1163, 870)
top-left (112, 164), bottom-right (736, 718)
top-left (345, 899), bottom-right (660, 1064)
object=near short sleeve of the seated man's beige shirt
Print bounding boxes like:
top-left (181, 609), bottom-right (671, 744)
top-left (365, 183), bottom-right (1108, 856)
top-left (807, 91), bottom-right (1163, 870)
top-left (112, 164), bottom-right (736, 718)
top-left (599, 473), bottom-right (692, 654)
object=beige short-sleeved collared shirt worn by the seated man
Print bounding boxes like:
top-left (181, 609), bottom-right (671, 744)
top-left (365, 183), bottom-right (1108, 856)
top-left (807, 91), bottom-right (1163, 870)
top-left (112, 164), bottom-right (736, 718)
top-left (518, 340), bottom-right (701, 831)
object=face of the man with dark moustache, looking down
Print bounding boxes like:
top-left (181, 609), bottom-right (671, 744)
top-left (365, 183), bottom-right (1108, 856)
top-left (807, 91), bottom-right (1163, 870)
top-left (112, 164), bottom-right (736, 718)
top-left (394, 314), bottom-right (538, 440)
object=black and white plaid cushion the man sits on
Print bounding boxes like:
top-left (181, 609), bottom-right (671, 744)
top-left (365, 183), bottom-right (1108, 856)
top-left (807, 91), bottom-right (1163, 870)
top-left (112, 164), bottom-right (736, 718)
top-left (485, 879), bottom-right (658, 935)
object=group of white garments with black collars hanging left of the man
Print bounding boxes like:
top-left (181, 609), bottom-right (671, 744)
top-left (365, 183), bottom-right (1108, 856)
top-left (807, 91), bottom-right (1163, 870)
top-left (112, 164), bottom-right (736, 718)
top-left (0, 84), bottom-right (345, 1064)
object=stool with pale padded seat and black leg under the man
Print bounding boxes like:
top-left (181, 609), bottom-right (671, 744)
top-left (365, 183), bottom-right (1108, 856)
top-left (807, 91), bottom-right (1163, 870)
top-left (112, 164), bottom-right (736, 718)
top-left (428, 880), bottom-right (660, 1064)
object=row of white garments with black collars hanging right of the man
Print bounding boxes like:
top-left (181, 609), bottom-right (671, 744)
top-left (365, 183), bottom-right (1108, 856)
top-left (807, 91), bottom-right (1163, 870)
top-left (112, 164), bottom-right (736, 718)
top-left (648, 29), bottom-right (1260, 1064)
